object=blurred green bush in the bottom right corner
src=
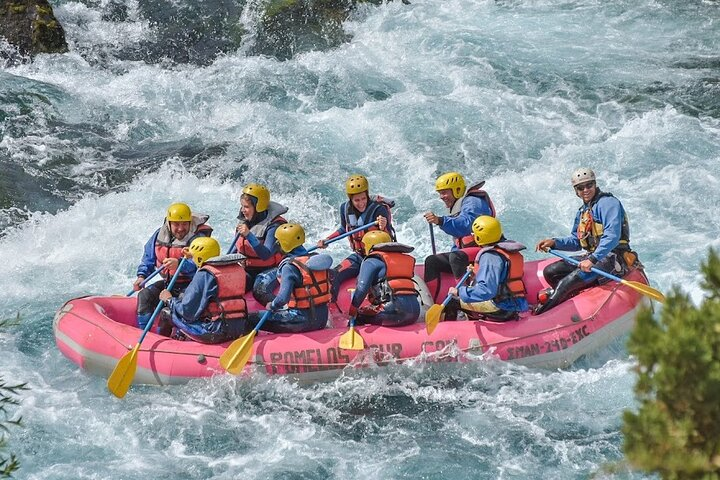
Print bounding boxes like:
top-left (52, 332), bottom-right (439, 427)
top-left (623, 250), bottom-right (720, 480)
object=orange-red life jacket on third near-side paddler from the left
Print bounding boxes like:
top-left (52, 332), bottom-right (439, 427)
top-left (368, 248), bottom-right (418, 305)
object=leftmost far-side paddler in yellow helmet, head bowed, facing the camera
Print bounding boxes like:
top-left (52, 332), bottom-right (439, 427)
top-left (133, 203), bottom-right (212, 333)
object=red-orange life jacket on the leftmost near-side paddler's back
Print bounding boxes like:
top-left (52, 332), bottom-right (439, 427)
top-left (200, 260), bottom-right (247, 322)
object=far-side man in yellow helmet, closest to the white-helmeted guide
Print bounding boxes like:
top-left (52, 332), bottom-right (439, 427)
top-left (423, 172), bottom-right (495, 319)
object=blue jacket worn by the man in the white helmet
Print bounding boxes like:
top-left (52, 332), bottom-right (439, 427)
top-left (553, 196), bottom-right (625, 263)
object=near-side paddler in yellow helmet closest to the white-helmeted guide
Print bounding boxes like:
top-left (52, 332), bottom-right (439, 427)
top-left (448, 215), bottom-right (529, 322)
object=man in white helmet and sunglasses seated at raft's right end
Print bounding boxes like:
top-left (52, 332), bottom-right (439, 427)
top-left (535, 168), bottom-right (637, 313)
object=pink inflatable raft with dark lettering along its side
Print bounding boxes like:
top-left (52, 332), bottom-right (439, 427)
top-left (53, 259), bottom-right (647, 385)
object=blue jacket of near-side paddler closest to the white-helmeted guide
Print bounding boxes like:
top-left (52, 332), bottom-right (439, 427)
top-left (458, 252), bottom-right (529, 312)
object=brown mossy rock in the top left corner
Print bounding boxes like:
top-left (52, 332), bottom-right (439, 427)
top-left (0, 0), bottom-right (68, 57)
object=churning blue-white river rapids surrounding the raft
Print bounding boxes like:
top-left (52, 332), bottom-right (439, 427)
top-left (0, 0), bottom-right (720, 480)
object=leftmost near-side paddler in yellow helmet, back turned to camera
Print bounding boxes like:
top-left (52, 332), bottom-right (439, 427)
top-left (160, 237), bottom-right (252, 343)
